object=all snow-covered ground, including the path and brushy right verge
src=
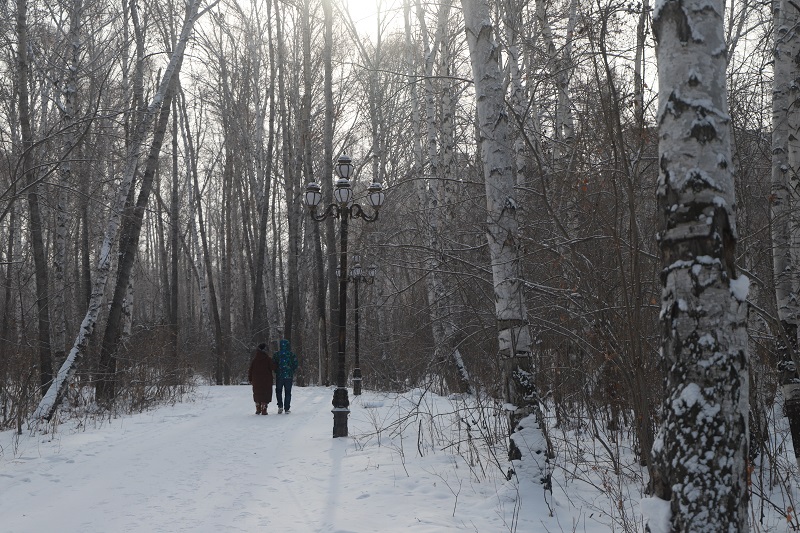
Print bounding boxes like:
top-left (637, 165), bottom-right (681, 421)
top-left (0, 386), bottom-right (786, 533)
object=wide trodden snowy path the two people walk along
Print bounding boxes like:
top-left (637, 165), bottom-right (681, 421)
top-left (0, 386), bottom-right (524, 533)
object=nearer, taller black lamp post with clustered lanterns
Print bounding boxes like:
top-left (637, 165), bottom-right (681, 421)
top-left (306, 155), bottom-right (386, 438)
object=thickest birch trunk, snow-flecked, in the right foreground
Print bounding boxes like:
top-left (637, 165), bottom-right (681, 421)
top-left (651, 0), bottom-right (748, 533)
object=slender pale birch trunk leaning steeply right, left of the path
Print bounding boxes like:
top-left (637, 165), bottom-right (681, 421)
top-left (32, 0), bottom-right (208, 422)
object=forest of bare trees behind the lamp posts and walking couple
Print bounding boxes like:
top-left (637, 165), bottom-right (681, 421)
top-left (0, 0), bottom-right (800, 530)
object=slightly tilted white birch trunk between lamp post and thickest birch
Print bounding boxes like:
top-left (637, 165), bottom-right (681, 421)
top-left (461, 0), bottom-right (549, 470)
